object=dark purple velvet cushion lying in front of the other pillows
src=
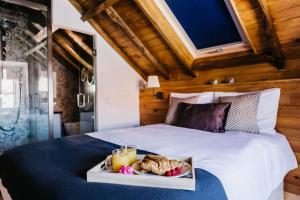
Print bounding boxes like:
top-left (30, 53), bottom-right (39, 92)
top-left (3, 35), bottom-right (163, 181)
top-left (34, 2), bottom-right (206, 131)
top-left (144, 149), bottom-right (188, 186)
top-left (176, 103), bottom-right (231, 133)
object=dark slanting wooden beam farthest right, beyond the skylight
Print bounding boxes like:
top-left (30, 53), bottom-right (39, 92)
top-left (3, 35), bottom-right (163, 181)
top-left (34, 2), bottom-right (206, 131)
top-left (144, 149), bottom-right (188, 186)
top-left (257, 0), bottom-right (286, 69)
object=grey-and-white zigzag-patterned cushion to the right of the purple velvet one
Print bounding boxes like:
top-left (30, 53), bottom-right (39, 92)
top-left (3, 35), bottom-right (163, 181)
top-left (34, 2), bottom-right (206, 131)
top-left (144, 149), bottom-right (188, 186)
top-left (219, 93), bottom-right (260, 133)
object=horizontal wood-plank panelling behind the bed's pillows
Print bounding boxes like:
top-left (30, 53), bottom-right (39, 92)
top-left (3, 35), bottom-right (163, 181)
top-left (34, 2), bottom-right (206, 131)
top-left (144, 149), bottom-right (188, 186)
top-left (140, 79), bottom-right (300, 195)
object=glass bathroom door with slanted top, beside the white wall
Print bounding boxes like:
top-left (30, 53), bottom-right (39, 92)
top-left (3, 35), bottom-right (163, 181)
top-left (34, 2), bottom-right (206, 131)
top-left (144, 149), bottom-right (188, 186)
top-left (52, 28), bottom-right (96, 137)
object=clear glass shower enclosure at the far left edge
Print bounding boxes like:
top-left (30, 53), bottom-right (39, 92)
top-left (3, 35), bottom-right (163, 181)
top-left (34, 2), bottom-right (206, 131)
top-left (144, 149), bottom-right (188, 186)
top-left (0, 0), bottom-right (51, 153)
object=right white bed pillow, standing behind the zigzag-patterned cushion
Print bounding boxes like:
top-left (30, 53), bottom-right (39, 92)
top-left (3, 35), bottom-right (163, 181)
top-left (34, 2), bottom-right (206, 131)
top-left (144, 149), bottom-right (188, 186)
top-left (214, 88), bottom-right (280, 134)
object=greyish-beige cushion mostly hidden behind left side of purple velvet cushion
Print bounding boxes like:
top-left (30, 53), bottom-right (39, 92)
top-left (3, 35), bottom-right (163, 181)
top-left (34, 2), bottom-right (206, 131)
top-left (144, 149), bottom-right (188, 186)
top-left (165, 96), bottom-right (199, 125)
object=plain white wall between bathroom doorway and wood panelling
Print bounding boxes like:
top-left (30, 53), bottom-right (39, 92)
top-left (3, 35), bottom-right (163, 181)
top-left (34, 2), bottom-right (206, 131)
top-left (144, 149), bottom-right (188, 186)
top-left (52, 0), bottom-right (140, 130)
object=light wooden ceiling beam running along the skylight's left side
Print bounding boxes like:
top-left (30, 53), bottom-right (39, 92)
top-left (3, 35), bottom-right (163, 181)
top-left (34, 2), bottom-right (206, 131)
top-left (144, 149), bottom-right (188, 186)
top-left (135, 0), bottom-right (196, 78)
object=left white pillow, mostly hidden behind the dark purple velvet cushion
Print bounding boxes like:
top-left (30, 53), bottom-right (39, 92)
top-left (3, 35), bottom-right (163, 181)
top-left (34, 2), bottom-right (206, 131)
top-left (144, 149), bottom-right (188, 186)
top-left (170, 92), bottom-right (215, 104)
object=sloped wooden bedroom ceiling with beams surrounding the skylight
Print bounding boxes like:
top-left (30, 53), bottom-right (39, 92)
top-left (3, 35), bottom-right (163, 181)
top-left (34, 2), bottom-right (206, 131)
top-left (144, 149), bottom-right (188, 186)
top-left (69, 0), bottom-right (300, 80)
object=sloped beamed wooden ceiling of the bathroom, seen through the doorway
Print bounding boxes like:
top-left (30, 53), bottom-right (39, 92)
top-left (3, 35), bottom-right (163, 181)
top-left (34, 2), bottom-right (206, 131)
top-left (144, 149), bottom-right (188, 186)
top-left (52, 29), bottom-right (93, 71)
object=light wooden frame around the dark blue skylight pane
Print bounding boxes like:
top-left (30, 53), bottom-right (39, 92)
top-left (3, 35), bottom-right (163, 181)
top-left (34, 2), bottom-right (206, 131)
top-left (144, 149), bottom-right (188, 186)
top-left (154, 0), bottom-right (251, 58)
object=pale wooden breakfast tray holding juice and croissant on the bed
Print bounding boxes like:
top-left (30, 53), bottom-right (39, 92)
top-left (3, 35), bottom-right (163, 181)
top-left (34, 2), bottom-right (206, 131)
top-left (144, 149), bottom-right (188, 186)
top-left (87, 155), bottom-right (196, 191)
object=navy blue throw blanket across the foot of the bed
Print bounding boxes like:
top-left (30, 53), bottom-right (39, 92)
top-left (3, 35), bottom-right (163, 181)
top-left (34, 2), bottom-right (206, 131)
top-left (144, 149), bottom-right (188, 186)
top-left (0, 136), bottom-right (227, 200)
